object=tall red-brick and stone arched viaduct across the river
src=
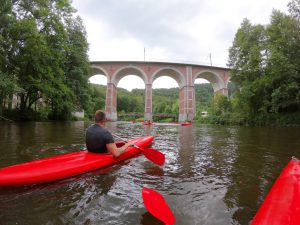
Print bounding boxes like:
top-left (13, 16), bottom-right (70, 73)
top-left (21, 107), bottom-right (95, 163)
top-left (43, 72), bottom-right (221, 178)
top-left (90, 61), bottom-right (230, 122)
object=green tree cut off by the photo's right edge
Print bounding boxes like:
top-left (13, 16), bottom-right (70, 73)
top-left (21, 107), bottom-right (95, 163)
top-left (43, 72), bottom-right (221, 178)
top-left (265, 11), bottom-right (300, 112)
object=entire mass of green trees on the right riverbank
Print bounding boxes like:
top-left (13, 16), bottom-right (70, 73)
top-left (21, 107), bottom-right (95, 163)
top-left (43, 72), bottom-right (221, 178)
top-left (228, 0), bottom-right (300, 120)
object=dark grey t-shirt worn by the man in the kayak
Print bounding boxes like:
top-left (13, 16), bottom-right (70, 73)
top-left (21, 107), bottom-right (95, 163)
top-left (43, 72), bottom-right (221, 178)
top-left (85, 124), bottom-right (114, 153)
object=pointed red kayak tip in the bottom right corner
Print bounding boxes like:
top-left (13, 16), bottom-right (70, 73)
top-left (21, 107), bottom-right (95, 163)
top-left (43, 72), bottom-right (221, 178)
top-left (251, 158), bottom-right (300, 225)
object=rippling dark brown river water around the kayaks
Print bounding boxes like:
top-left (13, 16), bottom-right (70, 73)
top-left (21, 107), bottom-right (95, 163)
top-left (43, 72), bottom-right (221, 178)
top-left (0, 122), bottom-right (300, 225)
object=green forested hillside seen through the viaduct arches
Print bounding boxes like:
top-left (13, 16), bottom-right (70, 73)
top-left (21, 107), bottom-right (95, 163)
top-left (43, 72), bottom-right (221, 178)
top-left (89, 83), bottom-right (223, 120)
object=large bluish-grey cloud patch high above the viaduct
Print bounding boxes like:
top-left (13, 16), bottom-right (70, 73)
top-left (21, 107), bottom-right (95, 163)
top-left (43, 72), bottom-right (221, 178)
top-left (79, 0), bottom-right (198, 49)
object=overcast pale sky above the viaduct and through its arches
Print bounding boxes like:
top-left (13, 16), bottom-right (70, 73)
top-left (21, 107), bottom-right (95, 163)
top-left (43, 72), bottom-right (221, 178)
top-left (72, 0), bottom-right (289, 89)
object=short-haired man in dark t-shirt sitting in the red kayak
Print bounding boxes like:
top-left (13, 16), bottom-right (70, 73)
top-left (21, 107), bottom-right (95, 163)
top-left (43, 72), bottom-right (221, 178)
top-left (85, 110), bottom-right (134, 157)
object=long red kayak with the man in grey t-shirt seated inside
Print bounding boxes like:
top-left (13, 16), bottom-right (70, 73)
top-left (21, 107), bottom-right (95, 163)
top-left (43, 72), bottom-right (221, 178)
top-left (0, 136), bottom-right (154, 187)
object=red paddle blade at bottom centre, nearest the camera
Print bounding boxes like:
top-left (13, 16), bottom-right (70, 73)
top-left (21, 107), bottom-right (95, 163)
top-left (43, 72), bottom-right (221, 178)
top-left (142, 188), bottom-right (176, 225)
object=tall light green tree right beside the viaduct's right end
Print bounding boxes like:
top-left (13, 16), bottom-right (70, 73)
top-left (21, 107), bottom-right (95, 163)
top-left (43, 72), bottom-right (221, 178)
top-left (228, 19), bottom-right (266, 113)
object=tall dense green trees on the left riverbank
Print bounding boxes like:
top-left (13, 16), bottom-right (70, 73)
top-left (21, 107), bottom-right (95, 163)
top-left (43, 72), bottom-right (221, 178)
top-left (0, 0), bottom-right (89, 119)
